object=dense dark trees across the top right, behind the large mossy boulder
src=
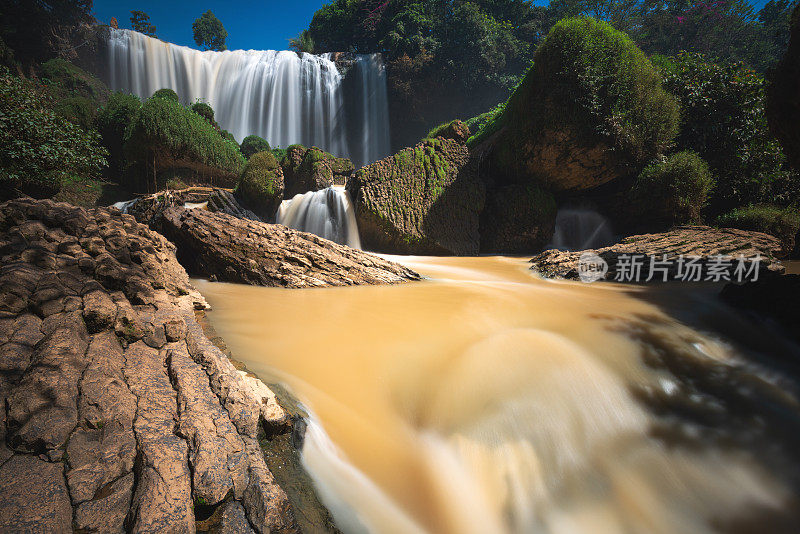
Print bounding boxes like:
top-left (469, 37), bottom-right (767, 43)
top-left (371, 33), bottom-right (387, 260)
top-left (304, 0), bottom-right (796, 148)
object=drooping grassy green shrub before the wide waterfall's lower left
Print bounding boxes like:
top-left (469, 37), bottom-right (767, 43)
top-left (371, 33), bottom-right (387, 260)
top-left (124, 95), bottom-right (244, 191)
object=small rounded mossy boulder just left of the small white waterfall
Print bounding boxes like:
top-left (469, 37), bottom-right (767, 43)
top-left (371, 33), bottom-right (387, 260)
top-left (235, 151), bottom-right (283, 220)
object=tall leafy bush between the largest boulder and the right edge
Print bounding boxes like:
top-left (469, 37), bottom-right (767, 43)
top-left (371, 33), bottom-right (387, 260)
top-left (656, 54), bottom-right (798, 214)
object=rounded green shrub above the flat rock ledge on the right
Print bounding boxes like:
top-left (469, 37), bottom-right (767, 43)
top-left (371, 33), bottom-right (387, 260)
top-left (630, 150), bottom-right (714, 226)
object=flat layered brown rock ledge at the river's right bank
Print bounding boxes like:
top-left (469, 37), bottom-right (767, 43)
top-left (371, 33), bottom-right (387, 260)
top-left (531, 226), bottom-right (783, 281)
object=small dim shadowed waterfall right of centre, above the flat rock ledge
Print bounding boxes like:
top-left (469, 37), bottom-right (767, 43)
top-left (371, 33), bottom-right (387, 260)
top-left (550, 208), bottom-right (615, 250)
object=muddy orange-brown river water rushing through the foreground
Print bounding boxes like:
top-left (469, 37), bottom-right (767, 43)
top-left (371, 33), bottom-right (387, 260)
top-left (195, 257), bottom-right (800, 533)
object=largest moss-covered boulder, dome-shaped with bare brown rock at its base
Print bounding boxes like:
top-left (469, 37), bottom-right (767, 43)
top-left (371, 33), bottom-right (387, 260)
top-left (491, 18), bottom-right (679, 191)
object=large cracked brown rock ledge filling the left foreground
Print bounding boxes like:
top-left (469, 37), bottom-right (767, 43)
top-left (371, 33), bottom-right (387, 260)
top-left (0, 199), bottom-right (332, 533)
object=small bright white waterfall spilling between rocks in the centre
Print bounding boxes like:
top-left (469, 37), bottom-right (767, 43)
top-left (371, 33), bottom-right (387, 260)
top-left (275, 186), bottom-right (361, 249)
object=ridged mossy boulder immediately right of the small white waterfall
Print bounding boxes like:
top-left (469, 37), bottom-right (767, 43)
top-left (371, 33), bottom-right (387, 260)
top-left (347, 138), bottom-right (485, 255)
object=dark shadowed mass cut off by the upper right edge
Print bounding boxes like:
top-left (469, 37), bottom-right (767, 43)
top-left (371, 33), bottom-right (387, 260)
top-left (767, 4), bottom-right (800, 170)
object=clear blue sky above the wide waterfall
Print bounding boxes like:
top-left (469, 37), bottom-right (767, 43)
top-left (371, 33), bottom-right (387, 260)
top-left (94, 0), bottom-right (767, 50)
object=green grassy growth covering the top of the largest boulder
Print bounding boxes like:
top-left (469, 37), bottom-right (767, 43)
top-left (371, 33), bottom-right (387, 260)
top-left (502, 19), bottom-right (679, 170)
